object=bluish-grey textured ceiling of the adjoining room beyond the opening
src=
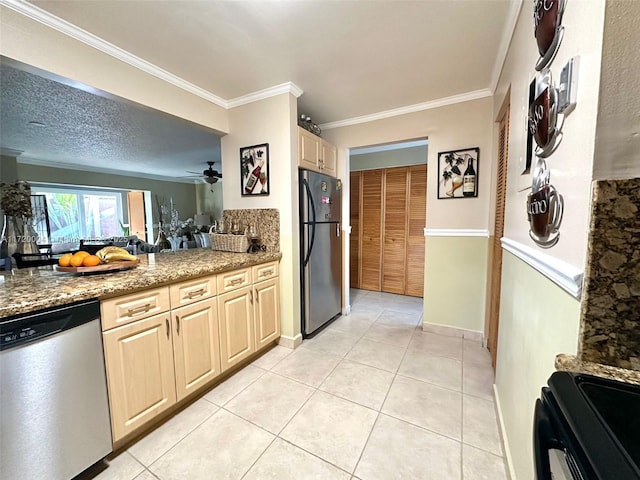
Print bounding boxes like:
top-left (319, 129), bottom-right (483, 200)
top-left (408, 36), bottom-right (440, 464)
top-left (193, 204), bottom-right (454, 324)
top-left (0, 63), bottom-right (220, 181)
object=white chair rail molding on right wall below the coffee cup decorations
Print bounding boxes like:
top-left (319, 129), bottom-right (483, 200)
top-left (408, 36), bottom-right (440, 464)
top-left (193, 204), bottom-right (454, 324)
top-left (500, 237), bottom-right (584, 300)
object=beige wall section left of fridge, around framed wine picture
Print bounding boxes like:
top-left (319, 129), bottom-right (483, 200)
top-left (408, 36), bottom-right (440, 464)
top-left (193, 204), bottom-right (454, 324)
top-left (221, 94), bottom-right (300, 338)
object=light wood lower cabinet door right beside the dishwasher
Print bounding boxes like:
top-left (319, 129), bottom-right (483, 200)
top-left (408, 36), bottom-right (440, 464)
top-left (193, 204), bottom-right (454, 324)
top-left (102, 313), bottom-right (176, 441)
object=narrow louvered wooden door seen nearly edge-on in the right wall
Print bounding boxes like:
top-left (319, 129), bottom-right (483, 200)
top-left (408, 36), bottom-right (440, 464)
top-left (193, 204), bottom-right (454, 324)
top-left (487, 107), bottom-right (509, 368)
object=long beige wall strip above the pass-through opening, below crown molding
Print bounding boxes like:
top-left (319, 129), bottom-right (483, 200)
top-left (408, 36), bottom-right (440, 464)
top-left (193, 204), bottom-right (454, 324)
top-left (0, 6), bottom-right (229, 133)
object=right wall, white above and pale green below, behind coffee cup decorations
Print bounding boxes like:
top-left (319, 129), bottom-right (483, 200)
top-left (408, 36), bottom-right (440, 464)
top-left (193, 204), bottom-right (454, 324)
top-left (494, 0), bottom-right (604, 480)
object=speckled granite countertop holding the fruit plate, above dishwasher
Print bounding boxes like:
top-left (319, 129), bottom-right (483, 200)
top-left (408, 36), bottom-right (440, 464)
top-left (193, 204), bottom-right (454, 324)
top-left (0, 249), bottom-right (282, 318)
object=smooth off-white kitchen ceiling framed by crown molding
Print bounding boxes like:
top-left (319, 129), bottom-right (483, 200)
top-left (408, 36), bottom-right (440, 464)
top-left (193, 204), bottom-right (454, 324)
top-left (30, 0), bottom-right (514, 123)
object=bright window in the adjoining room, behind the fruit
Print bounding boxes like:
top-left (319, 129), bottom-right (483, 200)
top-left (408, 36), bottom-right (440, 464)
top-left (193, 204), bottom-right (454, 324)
top-left (32, 185), bottom-right (123, 244)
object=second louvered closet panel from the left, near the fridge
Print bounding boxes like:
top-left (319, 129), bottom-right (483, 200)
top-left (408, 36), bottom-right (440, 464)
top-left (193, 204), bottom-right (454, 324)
top-left (360, 170), bottom-right (383, 291)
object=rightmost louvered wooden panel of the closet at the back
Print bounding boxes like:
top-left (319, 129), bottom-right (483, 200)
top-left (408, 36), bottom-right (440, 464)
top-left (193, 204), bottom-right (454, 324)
top-left (405, 165), bottom-right (427, 297)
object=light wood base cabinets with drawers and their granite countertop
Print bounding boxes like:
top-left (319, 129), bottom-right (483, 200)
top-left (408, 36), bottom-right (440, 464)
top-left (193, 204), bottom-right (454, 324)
top-left (0, 249), bottom-right (281, 448)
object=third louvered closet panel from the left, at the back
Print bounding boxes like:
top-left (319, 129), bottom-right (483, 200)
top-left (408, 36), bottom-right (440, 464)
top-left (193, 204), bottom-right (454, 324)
top-left (382, 167), bottom-right (408, 295)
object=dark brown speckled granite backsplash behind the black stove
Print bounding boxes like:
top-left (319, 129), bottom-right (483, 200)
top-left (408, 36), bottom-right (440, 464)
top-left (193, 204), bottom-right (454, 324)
top-left (579, 178), bottom-right (640, 370)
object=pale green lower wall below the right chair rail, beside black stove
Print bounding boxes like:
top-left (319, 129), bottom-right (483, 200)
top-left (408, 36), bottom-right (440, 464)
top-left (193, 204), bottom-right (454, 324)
top-left (495, 252), bottom-right (580, 480)
